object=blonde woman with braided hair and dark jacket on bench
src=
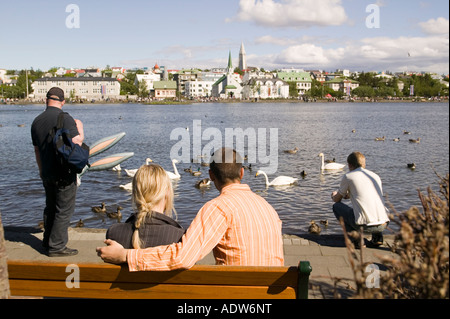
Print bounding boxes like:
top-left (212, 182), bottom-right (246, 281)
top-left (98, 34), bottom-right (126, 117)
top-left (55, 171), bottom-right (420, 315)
top-left (106, 164), bottom-right (185, 249)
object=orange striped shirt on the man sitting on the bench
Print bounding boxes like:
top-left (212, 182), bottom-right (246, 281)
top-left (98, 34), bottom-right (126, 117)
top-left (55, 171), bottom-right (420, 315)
top-left (127, 184), bottom-right (284, 271)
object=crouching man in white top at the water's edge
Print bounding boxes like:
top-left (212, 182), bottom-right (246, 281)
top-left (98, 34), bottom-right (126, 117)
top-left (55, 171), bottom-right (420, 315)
top-left (331, 152), bottom-right (389, 247)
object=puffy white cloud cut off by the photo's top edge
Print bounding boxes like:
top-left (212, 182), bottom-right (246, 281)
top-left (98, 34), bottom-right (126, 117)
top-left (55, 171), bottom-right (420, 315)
top-left (228, 0), bottom-right (348, 28)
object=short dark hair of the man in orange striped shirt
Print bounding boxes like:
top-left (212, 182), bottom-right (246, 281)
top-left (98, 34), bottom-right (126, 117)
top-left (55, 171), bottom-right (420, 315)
top-left (209, 147), bottom-right (243, 184)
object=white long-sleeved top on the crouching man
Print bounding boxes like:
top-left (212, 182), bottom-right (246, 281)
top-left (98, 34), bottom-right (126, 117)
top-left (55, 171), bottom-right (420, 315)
top-left (339, 167), bottom-right (389, 226)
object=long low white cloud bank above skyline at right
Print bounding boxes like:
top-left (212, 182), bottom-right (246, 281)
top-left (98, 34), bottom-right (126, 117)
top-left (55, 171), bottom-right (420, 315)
top-left (272, 36), bottom-right (449, 73)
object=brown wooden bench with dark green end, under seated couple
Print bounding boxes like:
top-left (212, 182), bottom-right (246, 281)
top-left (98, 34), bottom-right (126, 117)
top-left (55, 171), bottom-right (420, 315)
top-left (8, 260), bottom-right (311, 299)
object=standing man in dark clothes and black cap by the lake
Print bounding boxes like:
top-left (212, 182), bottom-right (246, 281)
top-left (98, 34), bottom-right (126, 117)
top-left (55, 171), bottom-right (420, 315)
top-left (31, 87), bottom-right (84, 257)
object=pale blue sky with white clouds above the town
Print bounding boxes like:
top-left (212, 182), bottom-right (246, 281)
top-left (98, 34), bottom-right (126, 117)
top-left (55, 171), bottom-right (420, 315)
top-left (0, 0), bottom-right (449, 74)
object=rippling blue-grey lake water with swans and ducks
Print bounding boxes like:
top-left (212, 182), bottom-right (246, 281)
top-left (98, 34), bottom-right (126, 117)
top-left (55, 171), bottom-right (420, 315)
top-left (0, 103), bottom-right (449, 234)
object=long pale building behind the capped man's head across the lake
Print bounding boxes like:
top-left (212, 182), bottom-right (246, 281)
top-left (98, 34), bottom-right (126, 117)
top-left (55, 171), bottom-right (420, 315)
top-left (31, 77), bottom-right (120, 100)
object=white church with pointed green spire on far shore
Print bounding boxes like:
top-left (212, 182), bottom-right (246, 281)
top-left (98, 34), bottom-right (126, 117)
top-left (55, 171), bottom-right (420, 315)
top-left (212, 52), bottom-right (242, 99)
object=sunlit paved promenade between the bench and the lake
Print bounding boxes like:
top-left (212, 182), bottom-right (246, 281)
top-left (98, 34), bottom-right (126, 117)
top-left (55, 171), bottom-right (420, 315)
top-left (4, 227), bottom-right (393, 299)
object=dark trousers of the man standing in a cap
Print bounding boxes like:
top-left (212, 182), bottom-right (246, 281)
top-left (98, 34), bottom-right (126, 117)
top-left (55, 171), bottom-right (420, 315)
top-left (43, 181), bottom-right (77, 253)
